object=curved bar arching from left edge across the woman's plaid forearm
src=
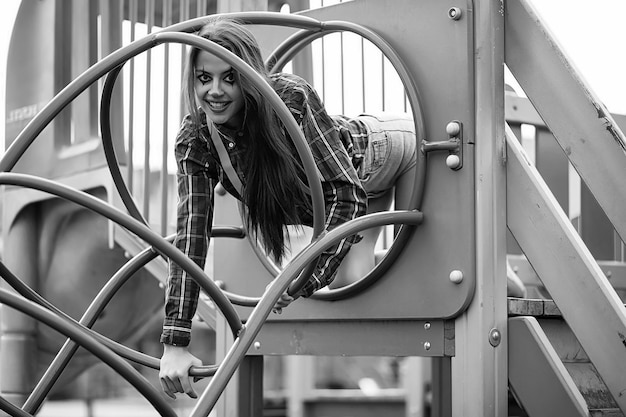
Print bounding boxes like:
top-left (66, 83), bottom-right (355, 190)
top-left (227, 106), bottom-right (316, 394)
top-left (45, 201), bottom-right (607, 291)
top-left (0, 173), bottom-right (242, 336)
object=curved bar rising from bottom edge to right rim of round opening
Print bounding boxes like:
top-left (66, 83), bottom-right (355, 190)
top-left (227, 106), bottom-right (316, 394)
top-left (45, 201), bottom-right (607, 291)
top-left (190, 211), bottom-right (423, 417)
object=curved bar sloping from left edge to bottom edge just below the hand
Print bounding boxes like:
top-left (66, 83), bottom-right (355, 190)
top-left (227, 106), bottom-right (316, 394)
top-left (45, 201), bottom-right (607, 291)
top-left (0, 290), bottom-right (177, 417)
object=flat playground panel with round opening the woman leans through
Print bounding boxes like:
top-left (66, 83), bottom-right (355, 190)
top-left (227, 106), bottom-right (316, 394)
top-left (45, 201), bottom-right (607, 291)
top-left (215, 0), bottom-right (475, 320)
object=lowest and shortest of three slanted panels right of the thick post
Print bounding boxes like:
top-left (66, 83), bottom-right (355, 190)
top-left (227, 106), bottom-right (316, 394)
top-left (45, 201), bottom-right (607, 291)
top-left (509, 317), bottom-right (589, 417)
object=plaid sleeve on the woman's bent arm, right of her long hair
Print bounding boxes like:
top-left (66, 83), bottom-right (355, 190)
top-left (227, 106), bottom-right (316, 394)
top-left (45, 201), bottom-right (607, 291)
top-left (291, 76), bottom-right (367, 297)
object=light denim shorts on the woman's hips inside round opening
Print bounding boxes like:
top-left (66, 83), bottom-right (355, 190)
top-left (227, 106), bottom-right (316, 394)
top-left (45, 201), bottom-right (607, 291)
top-left (357, 113), bottom-right (417, 198)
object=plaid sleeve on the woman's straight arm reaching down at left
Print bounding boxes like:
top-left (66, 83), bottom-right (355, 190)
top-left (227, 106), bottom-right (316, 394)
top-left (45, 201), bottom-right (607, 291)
top-left (161, 119), bottom-right (217, 346)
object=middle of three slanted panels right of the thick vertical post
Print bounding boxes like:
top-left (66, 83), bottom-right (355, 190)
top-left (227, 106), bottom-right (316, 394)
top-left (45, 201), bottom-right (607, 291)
top-left (507, 124), bottom-right (626, 411)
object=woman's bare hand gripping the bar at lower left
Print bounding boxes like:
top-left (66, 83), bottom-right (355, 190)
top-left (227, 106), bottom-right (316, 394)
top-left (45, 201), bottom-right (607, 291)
top-left (159, 344), bottom-right (202, 399)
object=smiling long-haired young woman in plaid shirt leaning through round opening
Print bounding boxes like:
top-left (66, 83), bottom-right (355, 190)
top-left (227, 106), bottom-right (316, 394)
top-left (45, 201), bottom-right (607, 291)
top-left (160, 17), bottom-right (416, 398)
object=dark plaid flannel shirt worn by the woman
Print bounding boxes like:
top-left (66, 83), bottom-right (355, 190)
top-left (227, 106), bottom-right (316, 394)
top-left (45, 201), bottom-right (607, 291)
top-left (161, 73), bottom-right (367, 346)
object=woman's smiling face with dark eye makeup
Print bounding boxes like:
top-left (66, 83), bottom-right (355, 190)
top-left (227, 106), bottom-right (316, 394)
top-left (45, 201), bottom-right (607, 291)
top-left (194, 51), bottom-right (244, 129)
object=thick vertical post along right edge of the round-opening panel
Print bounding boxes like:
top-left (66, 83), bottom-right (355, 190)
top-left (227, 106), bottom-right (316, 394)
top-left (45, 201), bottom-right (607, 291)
top-left (452, 0), bottom-right (508, 417)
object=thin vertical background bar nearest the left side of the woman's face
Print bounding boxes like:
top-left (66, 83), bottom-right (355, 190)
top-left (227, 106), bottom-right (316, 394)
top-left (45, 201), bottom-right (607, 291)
top-left (161, 0), bottom-right (172, 236)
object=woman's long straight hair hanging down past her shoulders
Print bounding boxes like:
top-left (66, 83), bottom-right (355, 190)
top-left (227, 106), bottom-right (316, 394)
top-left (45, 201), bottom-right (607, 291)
top-left (183, 17), bottom-right (311, 261)
